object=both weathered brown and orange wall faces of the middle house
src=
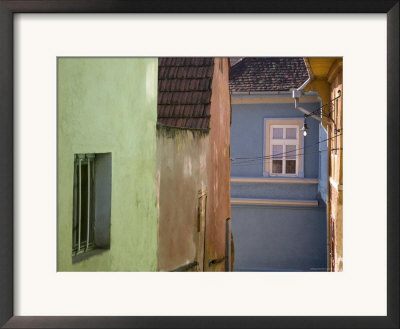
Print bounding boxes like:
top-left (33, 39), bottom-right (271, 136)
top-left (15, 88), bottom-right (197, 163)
top-left (157, 58), bottom-right (231, 271)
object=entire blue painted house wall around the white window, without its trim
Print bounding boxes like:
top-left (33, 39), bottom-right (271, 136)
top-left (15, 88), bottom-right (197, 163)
top-left (231, 94), bottom-right (328, 271)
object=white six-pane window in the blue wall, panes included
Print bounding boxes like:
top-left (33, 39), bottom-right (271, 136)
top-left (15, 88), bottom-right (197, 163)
top-left (269, 125), bottom-right (299, 176)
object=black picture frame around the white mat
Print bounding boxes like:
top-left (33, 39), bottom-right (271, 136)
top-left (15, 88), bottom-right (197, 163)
top-left (0, 0), bottom-right (400, 328)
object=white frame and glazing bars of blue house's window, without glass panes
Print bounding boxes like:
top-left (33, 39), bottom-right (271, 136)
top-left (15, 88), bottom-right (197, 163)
top-left (267, 124), bottom-right (300, 177)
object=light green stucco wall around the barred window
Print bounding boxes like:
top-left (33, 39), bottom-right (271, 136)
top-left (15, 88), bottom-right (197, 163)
top-left (57, 58), bottom-right (158, 271)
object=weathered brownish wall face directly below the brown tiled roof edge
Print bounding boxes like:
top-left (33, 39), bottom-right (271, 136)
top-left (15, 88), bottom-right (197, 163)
top-left (157, 127), bottom-right (209, 271)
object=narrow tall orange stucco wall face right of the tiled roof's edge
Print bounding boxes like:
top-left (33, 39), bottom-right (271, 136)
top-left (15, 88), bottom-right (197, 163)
top-left (204, 58), bottom-right (231, 271)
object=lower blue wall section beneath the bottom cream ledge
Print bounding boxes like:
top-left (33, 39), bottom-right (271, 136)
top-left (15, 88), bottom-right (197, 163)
top-left (232, 205), bottom-right (327, 271)
